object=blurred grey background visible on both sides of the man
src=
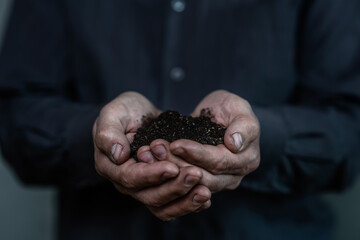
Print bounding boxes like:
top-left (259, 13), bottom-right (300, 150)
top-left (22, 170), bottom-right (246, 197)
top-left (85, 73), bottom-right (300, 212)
top-left (0, 0), bottom-right (360, 240)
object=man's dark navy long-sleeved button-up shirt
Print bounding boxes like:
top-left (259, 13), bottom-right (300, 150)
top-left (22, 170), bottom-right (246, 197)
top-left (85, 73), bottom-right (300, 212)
top-left (0, 0), bottom-right (360, 240)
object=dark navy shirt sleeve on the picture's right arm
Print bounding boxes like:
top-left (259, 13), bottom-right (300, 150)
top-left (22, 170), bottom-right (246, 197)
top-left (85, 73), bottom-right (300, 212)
top-left (241, 0), bottom-right (360, 194)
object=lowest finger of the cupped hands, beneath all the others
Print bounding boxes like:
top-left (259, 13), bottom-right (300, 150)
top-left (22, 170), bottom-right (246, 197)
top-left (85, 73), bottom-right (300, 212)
top-left (149, 185), bottom-right (211, 221)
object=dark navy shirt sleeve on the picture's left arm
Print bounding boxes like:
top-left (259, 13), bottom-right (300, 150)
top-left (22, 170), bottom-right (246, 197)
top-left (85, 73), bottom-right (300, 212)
top-left (0, 0), bottom-right (104, 188)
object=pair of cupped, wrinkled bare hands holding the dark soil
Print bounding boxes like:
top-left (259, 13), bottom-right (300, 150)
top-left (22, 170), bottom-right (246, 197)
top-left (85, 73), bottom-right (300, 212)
top-left (93, 90), bottom-right (260, 220)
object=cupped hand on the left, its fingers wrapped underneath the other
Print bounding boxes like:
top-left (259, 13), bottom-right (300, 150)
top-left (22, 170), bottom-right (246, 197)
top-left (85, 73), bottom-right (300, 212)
top-left (93, 92), bottom-right (211, 220)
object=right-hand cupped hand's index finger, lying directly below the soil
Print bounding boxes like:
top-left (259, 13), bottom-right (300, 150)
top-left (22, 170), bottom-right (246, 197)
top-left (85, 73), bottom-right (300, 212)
top-left (170, 139), bottom-right (248, 175)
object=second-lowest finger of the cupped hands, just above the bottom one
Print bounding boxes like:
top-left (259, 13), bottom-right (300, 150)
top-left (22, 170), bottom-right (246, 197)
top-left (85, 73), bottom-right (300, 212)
top-left (133, 167), bottom-right (202, 207)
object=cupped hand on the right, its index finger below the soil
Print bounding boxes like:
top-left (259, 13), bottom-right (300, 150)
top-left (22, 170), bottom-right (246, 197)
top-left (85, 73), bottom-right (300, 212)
top-left (170, 90), bottom-right (260, 190)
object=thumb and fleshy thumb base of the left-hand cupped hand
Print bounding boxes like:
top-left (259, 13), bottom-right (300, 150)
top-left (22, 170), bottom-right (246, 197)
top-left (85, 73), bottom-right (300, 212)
top-left (94, 92), bottom-right (160, 164)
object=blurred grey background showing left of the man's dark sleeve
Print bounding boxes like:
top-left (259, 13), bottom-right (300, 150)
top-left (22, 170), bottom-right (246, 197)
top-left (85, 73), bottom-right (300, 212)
top-left (0, 0), bottom-right (56, 240)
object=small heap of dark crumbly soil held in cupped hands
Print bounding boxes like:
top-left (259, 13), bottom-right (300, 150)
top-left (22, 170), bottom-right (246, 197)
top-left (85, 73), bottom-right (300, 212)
top-left (130, 109), bottom-right (226, 160)
